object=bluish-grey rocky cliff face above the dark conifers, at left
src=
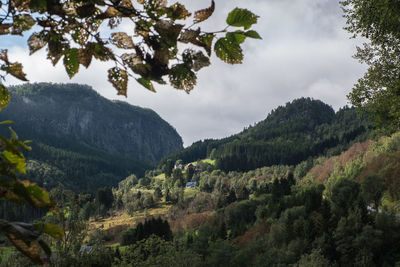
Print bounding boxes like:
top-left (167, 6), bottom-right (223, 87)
top-left (0, 83), bottom-right (182, 164)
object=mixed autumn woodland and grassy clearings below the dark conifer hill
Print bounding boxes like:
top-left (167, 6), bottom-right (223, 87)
top-left (2, 129), bottom-right (400, 267)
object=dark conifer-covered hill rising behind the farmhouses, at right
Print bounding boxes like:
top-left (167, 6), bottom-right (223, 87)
top-left (160, 98), bottom-right (372, 171)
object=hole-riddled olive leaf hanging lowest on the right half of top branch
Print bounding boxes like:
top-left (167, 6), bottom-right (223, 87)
top-left (169, 64), bottom-right (197, 93)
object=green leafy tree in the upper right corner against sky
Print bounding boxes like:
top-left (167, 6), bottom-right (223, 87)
top-left (341, 0), bottom-right (400, 133)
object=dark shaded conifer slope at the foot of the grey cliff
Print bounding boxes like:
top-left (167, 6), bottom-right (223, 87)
top-left (24, 142), bottom-right (151, 192)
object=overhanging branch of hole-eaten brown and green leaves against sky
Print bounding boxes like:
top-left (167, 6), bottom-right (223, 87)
top-left (0, 0), bottom-right (261, 96)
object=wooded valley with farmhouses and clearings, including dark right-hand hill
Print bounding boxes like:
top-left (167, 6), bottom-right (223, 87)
top-left (0, 90), bottom-right (400, 266)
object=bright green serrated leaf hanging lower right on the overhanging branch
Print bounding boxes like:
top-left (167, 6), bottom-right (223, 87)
top-left (214, 37), bottom-right (243, 64)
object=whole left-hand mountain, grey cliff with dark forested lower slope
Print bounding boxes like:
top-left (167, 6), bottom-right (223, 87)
top-left (0, 83), bottom-right (183, 190)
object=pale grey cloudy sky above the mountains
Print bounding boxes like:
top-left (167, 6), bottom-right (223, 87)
top-left (0, 0), bottom-right (366, 146)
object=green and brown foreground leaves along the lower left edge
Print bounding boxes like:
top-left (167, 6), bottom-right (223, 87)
top-left (0, 121), bottom-right (63, 264)
